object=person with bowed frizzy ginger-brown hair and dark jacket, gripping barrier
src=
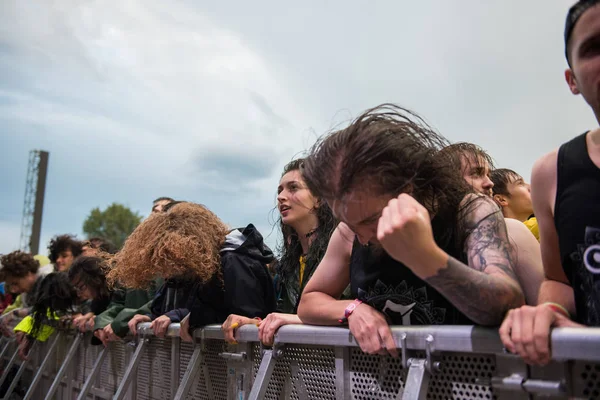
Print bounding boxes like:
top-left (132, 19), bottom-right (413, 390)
top-left (108, 202), bottom-right (275, 339)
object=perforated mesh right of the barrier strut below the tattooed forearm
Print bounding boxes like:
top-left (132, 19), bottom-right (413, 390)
top-left (427, 353), bottom-right (496, 400)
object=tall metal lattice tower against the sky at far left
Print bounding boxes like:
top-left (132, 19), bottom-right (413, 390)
top-left (19, 150), bottom-right (49, 254)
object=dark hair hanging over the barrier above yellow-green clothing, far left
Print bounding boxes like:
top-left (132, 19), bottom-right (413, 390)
top-left (31, 272), bottom-right (77, 337)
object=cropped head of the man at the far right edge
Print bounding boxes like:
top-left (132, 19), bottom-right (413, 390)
top-left (565, 5), bottom-right (600, 122)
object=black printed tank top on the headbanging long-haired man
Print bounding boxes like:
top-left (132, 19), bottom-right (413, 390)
top-left (350, 227), bottom-right (474, 326)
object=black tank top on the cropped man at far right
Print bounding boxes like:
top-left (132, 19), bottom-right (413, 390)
top-left (554, 132), bottom-right (600, 326)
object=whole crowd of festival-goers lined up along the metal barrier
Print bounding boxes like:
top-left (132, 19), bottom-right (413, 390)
top-left (0, 0), bottom-right (600, 376)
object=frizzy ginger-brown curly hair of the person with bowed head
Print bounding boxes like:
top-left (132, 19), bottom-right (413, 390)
top-left (107, 202), bottom-right (229, 289)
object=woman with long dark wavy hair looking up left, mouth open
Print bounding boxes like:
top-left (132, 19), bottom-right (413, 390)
top-left (222, 158), bottom-right (336, 345)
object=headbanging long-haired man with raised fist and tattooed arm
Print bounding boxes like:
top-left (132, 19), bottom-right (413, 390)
top-left (298, 105), bottom-right (524, 355)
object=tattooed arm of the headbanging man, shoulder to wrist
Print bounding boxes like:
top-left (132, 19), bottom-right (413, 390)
top-left (425, 196), bottom-right (525, 325)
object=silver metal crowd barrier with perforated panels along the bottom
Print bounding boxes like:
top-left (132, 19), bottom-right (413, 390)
top-left (0, 324), bottom-right (600, 400)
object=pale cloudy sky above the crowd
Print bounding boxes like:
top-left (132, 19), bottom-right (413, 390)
top-left (0, 0), bottom-right (597, 253)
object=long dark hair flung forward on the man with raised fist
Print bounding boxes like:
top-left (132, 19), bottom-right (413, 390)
top-left (303, 104), bottom-right (470, 252)
